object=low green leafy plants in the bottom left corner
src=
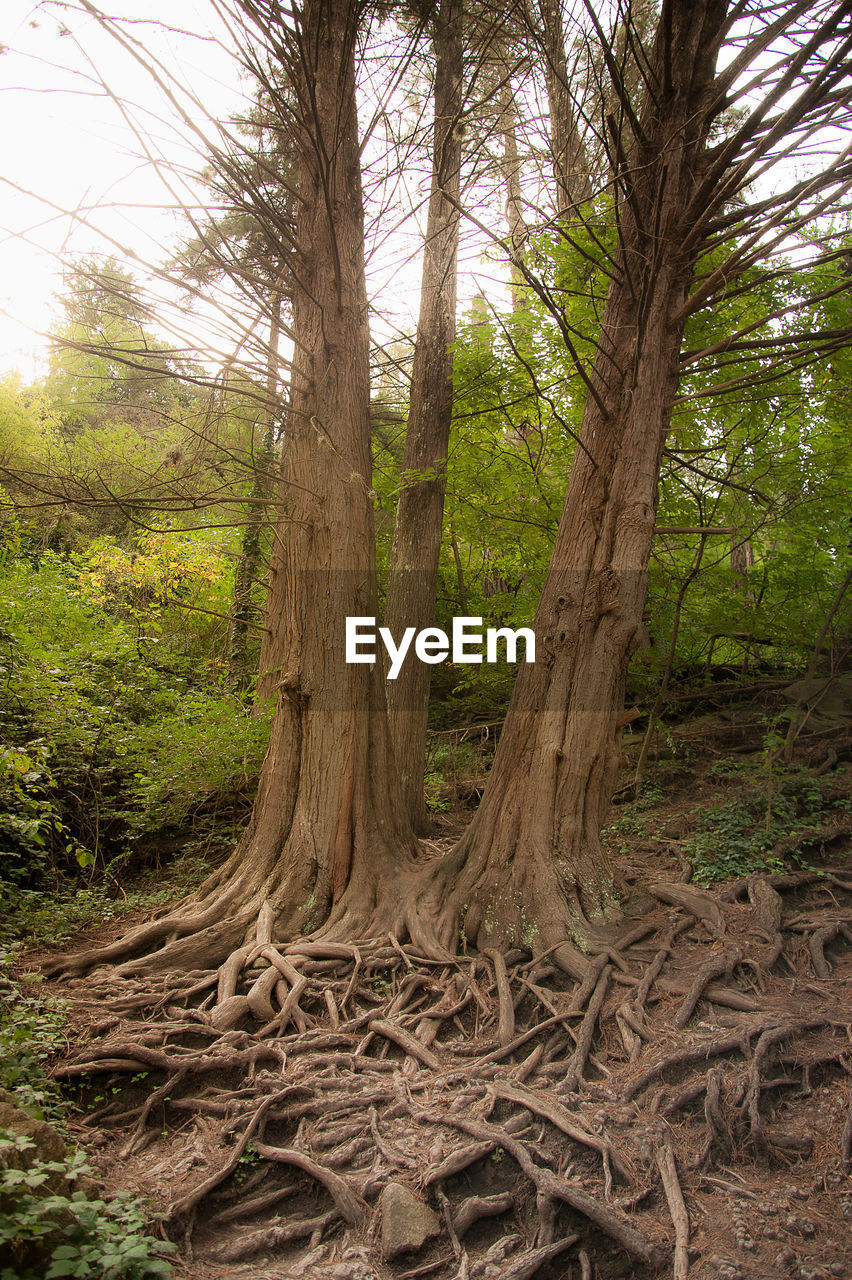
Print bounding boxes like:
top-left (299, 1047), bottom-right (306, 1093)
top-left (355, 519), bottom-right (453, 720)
top-left (0, 1129), bottom-right (175, 1280)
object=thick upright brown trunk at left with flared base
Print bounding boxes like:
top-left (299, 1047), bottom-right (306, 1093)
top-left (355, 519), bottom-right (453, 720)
top-left (56, 0), bottom-right (414, 973)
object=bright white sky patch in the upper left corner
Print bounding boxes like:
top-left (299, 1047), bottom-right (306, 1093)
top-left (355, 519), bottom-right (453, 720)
top-left (0, 0), bottom-right (249, 378)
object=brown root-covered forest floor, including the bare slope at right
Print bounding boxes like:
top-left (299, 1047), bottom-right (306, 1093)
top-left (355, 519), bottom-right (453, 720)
top-left (14, 716), bottom-right (852, 1280)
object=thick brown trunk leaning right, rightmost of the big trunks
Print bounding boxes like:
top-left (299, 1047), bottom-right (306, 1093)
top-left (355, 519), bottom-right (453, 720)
top-left (414, 0), bottom-right (725, 973)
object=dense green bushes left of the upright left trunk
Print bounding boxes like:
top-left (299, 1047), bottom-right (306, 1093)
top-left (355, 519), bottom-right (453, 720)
top-left (0, 535), bottom-right (269, 888)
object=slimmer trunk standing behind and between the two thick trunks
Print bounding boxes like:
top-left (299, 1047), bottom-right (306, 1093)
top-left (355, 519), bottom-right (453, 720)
top-left (385, 0), bottom-right (462, 831)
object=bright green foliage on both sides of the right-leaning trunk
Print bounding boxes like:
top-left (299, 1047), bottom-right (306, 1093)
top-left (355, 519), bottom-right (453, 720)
top-left (437, 225), bottom-right (852, 716)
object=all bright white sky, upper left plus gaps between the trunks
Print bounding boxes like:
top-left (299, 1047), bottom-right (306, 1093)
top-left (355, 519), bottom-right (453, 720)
top-left (0, 0), bottom-right (504, 380)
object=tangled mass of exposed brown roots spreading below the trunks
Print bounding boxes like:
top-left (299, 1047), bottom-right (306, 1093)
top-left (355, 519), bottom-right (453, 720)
top-left (44, 860), bottom-right (852, 1280)
